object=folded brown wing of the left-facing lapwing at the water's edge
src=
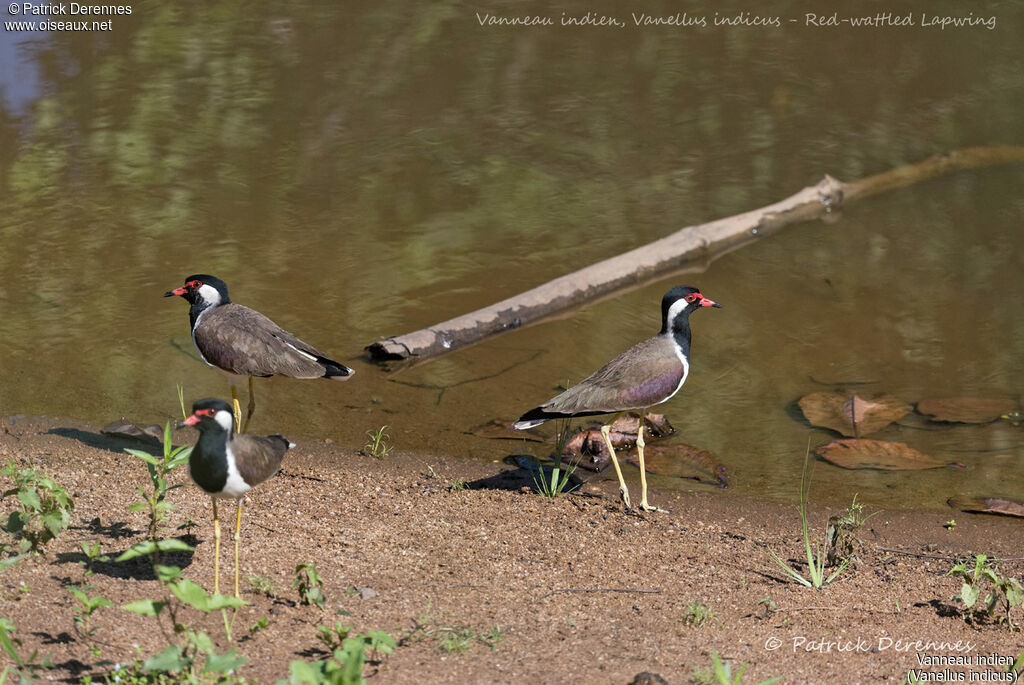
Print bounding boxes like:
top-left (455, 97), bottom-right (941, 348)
top-left (194, 303), bottom-right (330, 378)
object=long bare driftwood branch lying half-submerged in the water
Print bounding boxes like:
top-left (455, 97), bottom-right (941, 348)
top-left (367, 145), bottom-right (1024, 361)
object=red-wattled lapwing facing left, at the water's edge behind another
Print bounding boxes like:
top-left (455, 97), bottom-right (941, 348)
top-left (164, 273), bottom-right (355, 433)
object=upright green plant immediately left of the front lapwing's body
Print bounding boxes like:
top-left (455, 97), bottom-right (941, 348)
top-left (116, 423), bottom-right (193, 564)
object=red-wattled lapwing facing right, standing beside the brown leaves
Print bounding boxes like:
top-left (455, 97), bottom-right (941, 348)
top-left (514, 286), bottom-right (722, 511)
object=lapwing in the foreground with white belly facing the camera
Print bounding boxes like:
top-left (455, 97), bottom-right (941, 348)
top-left (183, 398), bottom-right (295, 597)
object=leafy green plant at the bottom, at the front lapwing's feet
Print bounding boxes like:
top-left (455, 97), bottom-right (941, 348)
top-left (122, 565), bottom-right (248, 683)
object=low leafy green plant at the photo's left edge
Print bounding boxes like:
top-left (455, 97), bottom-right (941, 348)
top-left (0, 462), bottom-right (75, 552)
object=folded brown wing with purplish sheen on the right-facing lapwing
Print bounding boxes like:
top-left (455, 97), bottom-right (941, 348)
top-left (541, 336), bottom-right (685, 414)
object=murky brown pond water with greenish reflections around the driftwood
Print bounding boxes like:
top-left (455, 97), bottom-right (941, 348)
top-left (0, 2), bottom-right (1024, 508)
